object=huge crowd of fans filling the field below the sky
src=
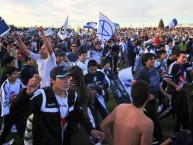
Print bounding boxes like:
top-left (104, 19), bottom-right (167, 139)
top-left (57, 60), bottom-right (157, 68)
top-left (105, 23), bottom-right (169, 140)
top-left (0, 26), bottom-right (193, 145)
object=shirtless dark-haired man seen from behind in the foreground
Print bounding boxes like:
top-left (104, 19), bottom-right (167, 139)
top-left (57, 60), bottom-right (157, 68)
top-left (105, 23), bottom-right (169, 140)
top-left (100, 80), bottom-right (153, 145)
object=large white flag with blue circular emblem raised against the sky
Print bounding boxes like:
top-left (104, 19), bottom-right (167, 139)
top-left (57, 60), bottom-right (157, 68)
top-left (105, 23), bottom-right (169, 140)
top-left (97, 13), bottom-right (115, 42)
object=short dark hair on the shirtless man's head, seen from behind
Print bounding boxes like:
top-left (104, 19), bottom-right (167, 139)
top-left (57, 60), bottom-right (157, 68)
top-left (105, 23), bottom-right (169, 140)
top-left (131, 80), bottom-right (150, 108)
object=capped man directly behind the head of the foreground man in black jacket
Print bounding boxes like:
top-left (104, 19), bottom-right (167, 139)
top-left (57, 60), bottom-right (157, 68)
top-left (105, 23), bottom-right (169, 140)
top-left (55, 49), bottom-right (72, 70)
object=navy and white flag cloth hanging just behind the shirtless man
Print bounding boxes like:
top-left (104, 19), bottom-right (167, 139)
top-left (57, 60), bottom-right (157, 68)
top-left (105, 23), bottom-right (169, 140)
top-left (111, 67), bottom-right (133, 104)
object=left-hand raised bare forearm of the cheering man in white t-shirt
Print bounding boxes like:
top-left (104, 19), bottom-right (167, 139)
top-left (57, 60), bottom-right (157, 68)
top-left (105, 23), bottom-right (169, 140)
top-left (12, 32), bottom-right (30, 56)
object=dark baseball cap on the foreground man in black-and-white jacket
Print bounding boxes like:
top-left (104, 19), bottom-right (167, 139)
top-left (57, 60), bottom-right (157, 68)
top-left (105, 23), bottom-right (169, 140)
top-left (50, 66), bottom-right (72, 79)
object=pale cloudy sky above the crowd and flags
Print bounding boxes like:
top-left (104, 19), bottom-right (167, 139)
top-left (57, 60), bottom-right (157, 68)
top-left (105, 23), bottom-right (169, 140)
top-left (0, 0), bottom-right (193, 28)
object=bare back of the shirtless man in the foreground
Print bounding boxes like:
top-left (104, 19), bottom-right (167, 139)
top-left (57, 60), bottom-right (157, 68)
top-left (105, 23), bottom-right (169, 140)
top-left (113, 104), bottom-right (153, 145)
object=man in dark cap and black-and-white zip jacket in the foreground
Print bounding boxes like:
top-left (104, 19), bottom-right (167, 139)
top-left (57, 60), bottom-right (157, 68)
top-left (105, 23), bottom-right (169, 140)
top-left (20, 66), bottom-right (104, 145)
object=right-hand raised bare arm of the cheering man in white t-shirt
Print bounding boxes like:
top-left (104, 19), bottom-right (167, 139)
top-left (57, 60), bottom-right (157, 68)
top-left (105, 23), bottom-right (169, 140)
top-left (38, 26), bottom-right (53, 55)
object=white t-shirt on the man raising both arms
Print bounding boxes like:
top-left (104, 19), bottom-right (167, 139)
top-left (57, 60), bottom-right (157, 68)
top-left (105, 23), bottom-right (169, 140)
top-left (29, 51), bottom-right (56, 88)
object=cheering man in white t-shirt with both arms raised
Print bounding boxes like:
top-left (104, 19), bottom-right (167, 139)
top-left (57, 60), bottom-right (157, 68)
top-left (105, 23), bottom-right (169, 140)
top-left (12, 26), bottom-right (56, 88)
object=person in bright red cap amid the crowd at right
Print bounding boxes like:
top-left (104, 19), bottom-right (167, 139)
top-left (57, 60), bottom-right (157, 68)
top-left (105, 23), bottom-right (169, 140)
top-left (145, 37), bottom-right (160, 54)
